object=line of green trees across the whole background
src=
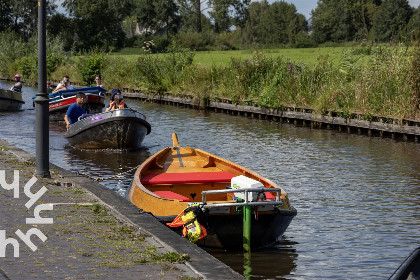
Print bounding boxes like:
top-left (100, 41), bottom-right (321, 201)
top-left (0, 0), bottom-right (420, 51)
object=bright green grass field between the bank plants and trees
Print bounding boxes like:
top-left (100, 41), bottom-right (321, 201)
top-left (113, 47), bottom-right (362, 66)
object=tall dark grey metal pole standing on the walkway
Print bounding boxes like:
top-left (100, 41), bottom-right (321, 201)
top-left (35, 0), bottom-right (51, 178)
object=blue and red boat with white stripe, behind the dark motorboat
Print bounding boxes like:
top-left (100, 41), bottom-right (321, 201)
top-left (32, 87), bottom-right (106, 121)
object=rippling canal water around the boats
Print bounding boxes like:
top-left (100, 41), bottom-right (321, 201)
top-left (0, 81), bottom-right (420, 279)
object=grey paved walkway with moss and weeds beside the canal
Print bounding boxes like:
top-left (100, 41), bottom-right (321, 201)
top-left (0, 139), bottom-right (242, 279)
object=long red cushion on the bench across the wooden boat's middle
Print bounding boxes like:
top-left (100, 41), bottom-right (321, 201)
top-left (141, 171), bottom-right (236, 185)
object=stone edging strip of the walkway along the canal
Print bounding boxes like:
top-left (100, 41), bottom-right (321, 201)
top-left (0, 138), bottom-right (245, 280)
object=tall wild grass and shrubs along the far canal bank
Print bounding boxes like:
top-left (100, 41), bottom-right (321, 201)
top-left (0, 33), bottom-right (420, 120)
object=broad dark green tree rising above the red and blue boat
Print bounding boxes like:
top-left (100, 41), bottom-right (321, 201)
top-left (63, 0), bottom-right (131, 50)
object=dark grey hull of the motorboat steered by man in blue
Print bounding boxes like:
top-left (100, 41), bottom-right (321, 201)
top-left (64, 108), bottom-right (151, 150)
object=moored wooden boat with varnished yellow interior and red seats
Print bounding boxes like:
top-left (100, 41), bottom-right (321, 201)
top-left (129, 134), bottom-right (297, 249)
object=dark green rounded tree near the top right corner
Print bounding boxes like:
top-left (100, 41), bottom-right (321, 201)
top-left (373, 0), bottom-right (413, 42)
